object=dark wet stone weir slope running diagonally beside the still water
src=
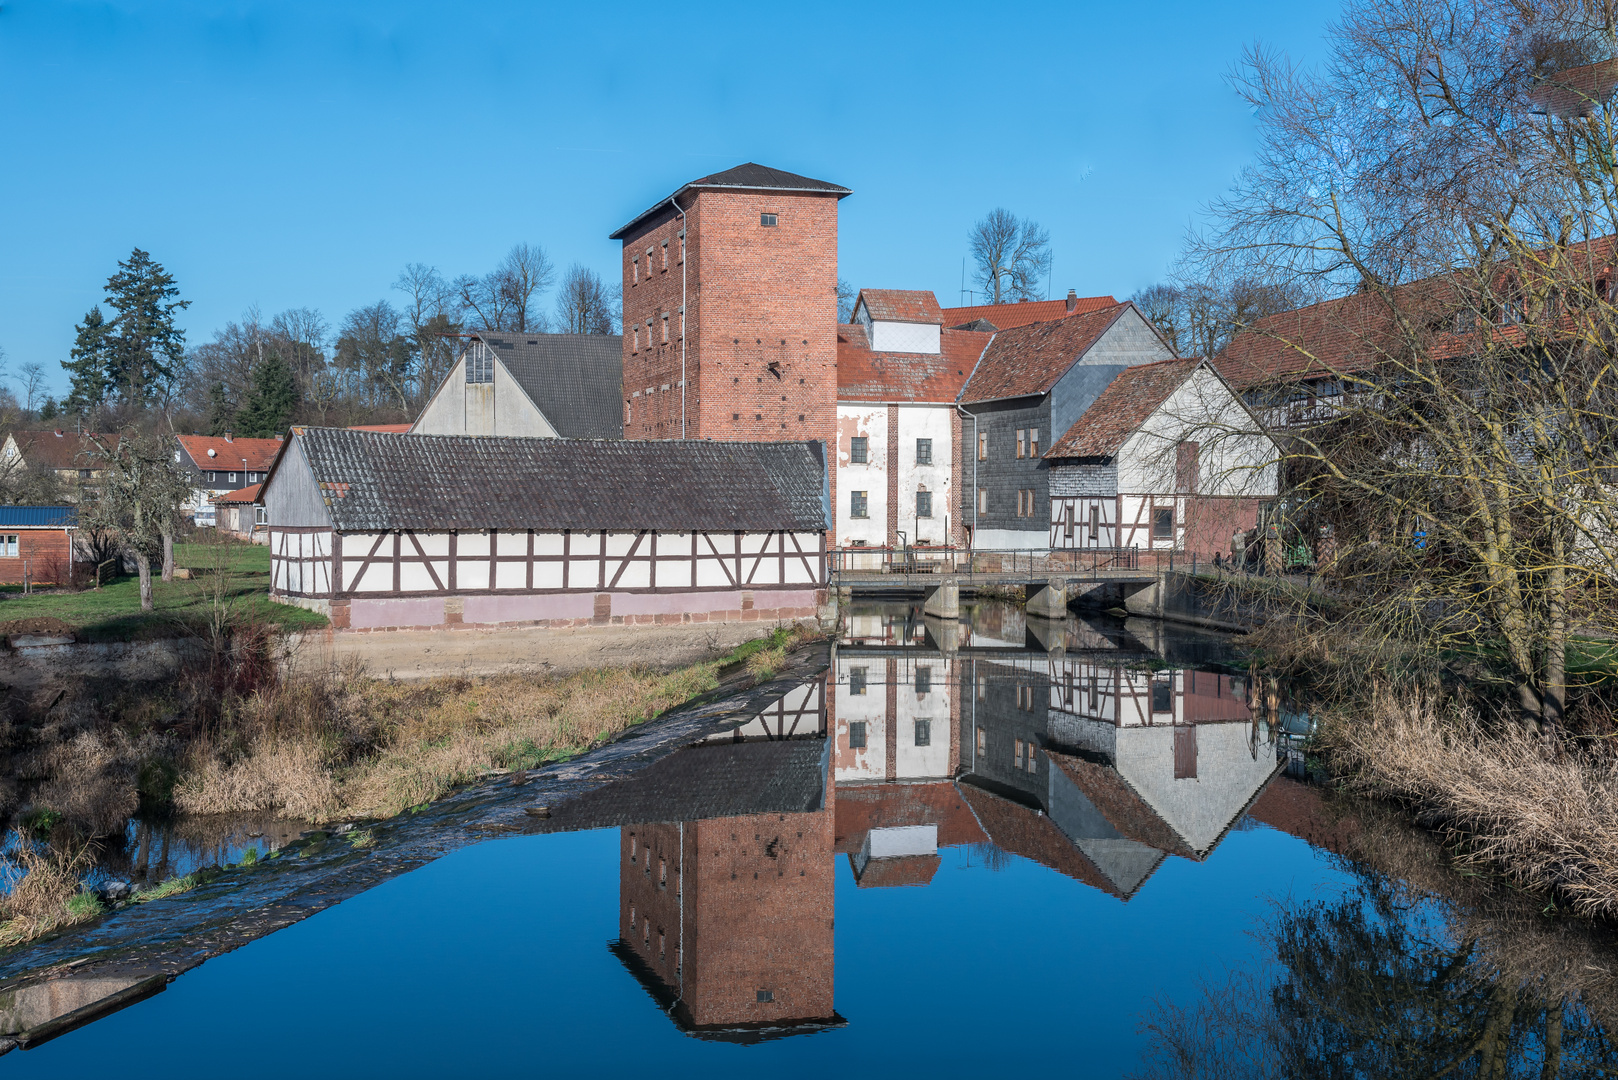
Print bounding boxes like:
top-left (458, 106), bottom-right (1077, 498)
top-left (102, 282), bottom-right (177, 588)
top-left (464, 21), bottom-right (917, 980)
top-left (0, 643), bottom-right (827, 1052)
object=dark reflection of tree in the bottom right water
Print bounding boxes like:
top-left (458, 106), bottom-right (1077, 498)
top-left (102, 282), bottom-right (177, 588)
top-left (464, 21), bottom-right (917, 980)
top-left (1142, 863), bottom-right (1618, 1080)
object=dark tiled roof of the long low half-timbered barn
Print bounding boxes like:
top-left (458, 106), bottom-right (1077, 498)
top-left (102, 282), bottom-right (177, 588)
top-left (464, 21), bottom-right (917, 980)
top-left (283, 427), bottom-right (827, 533)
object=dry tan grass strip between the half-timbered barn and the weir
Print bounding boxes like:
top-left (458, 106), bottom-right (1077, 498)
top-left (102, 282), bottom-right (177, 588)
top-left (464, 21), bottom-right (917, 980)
top-left (173, 630), bottom-right (806, 821)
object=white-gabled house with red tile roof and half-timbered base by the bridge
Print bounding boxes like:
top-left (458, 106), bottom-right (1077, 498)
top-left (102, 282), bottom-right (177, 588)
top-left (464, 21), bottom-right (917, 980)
top-left (1045, 359), bottom-right (1280, 554)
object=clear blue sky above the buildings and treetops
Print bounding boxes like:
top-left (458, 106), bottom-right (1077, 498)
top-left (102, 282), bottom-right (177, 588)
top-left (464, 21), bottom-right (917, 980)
top-left (0, 0), bottom-right (1338, 392)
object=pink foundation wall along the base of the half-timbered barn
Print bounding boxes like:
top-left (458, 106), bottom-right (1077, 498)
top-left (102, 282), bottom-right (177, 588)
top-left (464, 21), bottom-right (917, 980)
top-left (332, 589), bottom-right (825, 633)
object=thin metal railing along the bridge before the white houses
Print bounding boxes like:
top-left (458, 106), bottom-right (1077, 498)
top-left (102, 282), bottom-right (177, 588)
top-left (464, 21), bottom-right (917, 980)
top-left (827, 546), bottom-right (1142, 580)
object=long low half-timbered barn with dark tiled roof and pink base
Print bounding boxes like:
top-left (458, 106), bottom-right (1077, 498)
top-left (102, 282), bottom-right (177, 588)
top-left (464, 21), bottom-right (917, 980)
top-left (262, 427), bottom-right (828, 630)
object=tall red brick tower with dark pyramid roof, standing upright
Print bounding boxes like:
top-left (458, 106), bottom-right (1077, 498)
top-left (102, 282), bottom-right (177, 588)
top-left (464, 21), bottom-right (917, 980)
top-left (612, 164), bottom-right (849, 445)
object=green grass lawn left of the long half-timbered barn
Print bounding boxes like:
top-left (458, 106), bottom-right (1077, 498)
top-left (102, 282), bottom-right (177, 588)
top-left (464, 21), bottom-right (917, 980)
top-left (0, 544), bottom-right (327, 641)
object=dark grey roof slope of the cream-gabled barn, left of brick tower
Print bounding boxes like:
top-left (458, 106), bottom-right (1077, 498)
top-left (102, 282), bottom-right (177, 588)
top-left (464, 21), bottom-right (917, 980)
top-left (477, 330), bottom-right (623, 439)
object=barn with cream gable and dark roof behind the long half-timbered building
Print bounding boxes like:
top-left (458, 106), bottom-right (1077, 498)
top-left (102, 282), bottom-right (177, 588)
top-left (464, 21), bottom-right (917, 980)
top-left (411, 330), bottom-right (623, 439)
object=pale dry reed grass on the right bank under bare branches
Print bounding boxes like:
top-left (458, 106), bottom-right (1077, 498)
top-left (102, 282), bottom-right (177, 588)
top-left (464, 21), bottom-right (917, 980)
top-left (1322, 690), bottom-right (1618, 918)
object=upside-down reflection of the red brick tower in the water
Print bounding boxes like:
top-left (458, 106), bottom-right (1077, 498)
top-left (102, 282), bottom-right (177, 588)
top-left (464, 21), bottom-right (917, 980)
top-left (618, 777), bottom-right (843, 1041)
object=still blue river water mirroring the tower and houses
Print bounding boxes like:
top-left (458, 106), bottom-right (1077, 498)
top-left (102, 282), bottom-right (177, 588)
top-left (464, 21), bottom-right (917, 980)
top-left (0, 606), bottom-right (1618, 1077)
